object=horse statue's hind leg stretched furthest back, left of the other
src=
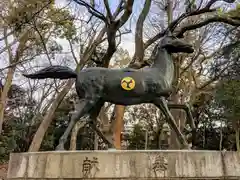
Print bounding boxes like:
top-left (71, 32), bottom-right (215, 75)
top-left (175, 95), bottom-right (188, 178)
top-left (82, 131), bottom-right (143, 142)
top-left (56, 99), bottom-right (96, 150)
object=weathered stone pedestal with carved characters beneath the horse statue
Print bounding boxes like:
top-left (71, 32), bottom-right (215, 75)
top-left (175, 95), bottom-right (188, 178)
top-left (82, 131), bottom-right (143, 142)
top-left (8, 150), bottom-right (240, 180)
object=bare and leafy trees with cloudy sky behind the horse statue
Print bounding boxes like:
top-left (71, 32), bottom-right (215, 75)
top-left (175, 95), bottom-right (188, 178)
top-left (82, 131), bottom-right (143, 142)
top-left (0, 0), bottom-right (240, 162)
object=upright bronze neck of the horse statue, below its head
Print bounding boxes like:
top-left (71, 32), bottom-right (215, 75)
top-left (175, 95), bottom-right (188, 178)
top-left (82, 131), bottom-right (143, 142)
top-left (152, 49), bottom-right (174, 85)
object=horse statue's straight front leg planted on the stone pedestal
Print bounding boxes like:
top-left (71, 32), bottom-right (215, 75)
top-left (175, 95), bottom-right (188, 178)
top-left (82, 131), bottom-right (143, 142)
top-left (154, 97), bottom-right (189, 149)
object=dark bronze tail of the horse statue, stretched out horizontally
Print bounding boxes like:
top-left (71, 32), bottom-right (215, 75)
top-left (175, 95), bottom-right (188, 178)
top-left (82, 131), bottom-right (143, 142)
top-left (23, 66), bottom-right (77, 79)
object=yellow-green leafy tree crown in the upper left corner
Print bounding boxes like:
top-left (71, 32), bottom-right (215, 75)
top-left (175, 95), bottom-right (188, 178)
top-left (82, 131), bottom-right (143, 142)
top-left (3, 0), bottom-right (77, 59)
